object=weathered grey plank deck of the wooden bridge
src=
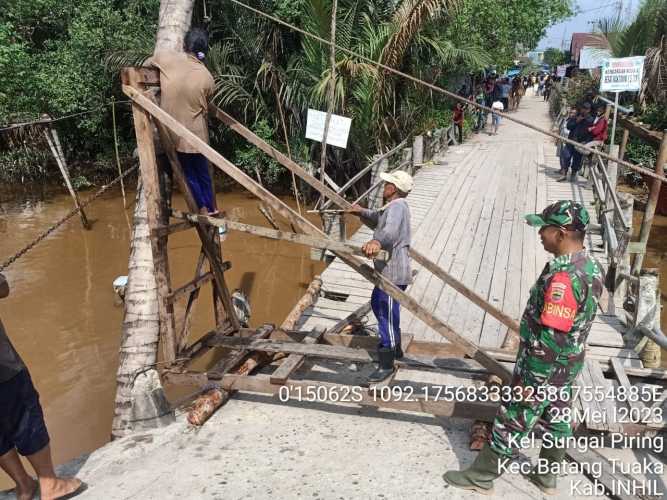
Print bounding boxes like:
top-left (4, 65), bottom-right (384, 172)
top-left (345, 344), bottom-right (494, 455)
top-left (301, 96), bottom-right (641, 366)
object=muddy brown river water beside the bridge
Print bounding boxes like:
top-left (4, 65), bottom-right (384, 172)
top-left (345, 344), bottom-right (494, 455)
top-left (0, 187), bottom-right (324, 489)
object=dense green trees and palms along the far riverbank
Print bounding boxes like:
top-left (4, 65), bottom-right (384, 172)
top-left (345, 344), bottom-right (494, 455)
top-left (0, 0), bottom-right (571, 188)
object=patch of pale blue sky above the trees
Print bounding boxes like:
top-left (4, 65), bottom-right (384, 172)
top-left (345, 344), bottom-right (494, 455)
top-left (537, 0), bottom-right (642, 50)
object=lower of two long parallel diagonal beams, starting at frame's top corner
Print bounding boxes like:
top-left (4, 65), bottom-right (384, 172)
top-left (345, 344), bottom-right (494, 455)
top-left (123, 86), bottom-right (512, 383)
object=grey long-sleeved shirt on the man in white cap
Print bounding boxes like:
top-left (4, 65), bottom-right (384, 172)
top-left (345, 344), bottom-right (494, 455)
top-left (361, 198), bottom-right (412, 285)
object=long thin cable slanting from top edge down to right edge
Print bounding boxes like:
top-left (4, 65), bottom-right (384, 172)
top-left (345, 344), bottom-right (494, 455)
top-left (230, 0), bottom-right (667, 184)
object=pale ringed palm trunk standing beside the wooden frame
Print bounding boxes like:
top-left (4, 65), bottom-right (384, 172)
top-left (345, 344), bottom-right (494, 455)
top-left (111, 0), bottom-right (194, 438)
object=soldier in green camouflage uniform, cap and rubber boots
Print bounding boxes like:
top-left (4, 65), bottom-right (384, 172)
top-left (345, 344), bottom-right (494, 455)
top-left (444, 201), bottom-right (604, 494)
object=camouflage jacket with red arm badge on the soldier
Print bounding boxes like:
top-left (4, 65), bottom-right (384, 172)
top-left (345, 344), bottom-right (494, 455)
top-left (520, 250), bottom-right (604, 362)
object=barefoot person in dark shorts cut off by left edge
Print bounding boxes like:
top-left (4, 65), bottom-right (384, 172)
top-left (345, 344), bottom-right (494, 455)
top-left (0, 274), bottom-right (85, 500)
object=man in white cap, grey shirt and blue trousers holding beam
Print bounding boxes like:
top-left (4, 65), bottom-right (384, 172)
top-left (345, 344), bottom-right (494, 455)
top-left (350, 170), bottom-right (413, 383)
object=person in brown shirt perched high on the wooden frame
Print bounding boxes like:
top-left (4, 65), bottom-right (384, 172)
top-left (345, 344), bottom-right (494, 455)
top-left (150, 28), bottom-right (217, 215)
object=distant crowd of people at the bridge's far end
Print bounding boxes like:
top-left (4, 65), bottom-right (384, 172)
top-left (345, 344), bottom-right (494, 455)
top-left (452, 73), bottom-right (556, 143)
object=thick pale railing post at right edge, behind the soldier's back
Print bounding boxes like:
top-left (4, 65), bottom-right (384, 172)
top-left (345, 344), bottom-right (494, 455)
top-left (635, 269), bottom-right (660, 368)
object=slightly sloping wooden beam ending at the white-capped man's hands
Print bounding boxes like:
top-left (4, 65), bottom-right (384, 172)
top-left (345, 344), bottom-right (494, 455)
top-left (171, 210), bottom-right (389, 260)
